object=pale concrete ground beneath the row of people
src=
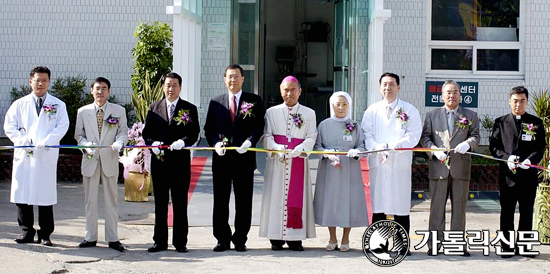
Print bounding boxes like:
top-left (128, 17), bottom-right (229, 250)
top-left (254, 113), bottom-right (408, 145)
top-left (0, 150), bottom-right (550, 274)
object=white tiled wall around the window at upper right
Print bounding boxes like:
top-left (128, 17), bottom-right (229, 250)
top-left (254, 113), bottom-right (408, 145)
top-left (384, 0), bottom-right (550, 144)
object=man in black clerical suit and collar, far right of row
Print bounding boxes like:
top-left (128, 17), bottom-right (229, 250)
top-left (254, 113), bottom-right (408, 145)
top-left (489, 86), bottom-right (546, 258)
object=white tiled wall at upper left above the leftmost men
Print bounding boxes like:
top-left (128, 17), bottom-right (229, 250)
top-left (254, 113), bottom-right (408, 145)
top-left (0, 0), bottom-right (173, 137)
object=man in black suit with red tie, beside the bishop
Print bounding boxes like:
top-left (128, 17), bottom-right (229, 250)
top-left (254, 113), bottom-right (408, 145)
top-left (204, 64), bottom-right (265, 252)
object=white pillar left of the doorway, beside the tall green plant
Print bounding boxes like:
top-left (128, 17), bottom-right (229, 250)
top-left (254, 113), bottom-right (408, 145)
top-left (166, 0), bottom-right (202, 106)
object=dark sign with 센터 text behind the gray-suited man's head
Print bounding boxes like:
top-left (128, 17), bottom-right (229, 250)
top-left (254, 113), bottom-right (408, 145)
top-left (425, 81), bottom-right (479, 108)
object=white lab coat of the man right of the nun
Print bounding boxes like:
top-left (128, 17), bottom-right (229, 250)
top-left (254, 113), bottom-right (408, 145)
top-left (361, 99), bottom-right (422, 215)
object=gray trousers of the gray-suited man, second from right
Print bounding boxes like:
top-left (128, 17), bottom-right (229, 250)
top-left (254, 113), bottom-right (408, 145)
top-left (429, 175), bottom-right (470, 249)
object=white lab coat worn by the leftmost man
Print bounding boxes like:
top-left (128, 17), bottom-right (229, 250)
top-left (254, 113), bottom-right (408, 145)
top-left (4, 94), bottom-right (69, 206)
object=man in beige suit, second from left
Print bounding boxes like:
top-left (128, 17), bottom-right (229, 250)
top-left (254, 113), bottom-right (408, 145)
top-left (75, 77), bottom-right (128, 252)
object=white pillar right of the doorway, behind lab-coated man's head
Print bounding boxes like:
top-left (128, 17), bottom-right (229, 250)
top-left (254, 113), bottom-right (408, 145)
top-left (367, 0), bottom-right (391, 105)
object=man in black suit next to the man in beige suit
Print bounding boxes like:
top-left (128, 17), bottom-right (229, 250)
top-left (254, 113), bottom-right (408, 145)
top-left (143, 72), bottom-right (200, 252)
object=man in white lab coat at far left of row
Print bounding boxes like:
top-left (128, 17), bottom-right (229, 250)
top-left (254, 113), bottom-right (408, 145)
top-left (4, 67), bottom-right (69, 246)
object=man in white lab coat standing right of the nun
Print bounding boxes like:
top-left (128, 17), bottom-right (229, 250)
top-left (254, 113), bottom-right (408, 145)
top-left (361, 72), bottom-right (422, 255)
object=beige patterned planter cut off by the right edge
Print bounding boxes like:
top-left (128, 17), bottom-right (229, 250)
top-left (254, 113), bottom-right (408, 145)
top-left (533, 184), bottom-right (550, 244)
